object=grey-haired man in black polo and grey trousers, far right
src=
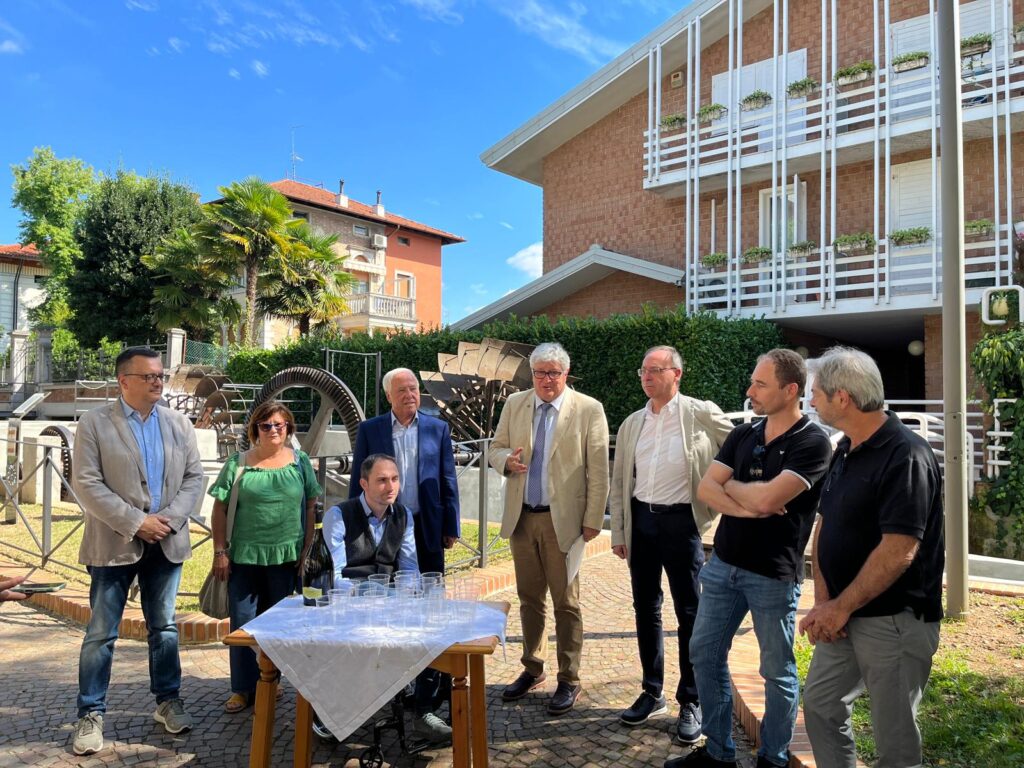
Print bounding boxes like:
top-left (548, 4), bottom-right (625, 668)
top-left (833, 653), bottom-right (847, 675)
top-left (800, 348), bottom-right (945, 768)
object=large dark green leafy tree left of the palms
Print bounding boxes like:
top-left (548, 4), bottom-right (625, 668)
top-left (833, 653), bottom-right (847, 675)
top-left (68, 171), bottom-right (202, 346)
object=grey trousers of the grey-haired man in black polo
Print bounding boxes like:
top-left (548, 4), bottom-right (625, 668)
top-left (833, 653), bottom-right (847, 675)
top-left (804, 611), bottom-right (939, 768)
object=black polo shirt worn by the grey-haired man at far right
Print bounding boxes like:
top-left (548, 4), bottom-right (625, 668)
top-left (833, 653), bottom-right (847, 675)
top-left (818, 413), bottom-right (945, 622)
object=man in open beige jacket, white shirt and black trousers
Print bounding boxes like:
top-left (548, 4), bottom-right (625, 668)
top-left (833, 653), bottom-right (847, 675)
top-left (609, 346), bottom-right (732, 743)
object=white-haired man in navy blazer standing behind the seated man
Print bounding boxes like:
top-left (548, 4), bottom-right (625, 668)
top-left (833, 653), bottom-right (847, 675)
top-left (348, 368), bottom-right (459, 573)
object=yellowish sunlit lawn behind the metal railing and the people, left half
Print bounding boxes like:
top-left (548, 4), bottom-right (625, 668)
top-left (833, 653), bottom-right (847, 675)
top-left (0, 504), bottom-right (511, 613)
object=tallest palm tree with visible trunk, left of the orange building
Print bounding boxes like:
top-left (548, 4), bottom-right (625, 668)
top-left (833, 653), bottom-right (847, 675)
top-left (200, 176), bottom-right (303, 346)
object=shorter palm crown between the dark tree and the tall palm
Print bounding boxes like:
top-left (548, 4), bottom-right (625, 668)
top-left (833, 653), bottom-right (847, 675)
top-left (142, 225), bottom-right (242, 340)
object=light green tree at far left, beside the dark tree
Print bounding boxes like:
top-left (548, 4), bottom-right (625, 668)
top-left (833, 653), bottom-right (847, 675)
top-left (11, 146), bottom-right (95, 327)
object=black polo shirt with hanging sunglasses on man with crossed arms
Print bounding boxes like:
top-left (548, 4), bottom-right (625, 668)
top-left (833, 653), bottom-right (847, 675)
top-left (715, 416), bottom-right (831, 582)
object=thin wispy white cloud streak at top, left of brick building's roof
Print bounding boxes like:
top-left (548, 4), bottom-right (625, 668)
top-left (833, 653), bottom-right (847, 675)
top-left (495, 0), bottom-right (626, 66)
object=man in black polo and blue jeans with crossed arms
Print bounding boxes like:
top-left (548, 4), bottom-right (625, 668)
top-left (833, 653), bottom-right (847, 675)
top-left (665, 349), bottom-right (831, 768)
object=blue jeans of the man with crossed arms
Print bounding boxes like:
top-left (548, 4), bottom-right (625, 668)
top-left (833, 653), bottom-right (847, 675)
top-left (690, 555), bottom-right (800, 766)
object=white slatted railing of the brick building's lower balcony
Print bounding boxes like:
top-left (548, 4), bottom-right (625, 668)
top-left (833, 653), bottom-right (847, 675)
top-left (686, 226), bottom-right (1015, 317)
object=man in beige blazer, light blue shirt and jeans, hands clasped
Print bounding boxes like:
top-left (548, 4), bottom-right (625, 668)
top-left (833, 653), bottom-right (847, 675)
top-left (72, 347), bottom-right (204, 755)
